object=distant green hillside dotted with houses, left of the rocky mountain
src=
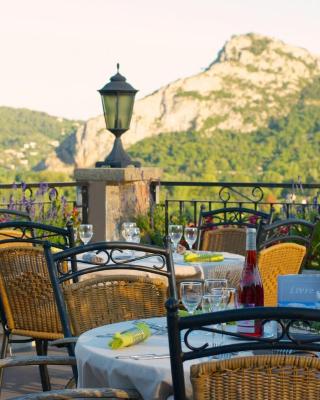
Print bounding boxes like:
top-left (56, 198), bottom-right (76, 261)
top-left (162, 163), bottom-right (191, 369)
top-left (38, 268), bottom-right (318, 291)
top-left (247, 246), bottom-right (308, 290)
top-left (0, 107), bottom-right (81, 182)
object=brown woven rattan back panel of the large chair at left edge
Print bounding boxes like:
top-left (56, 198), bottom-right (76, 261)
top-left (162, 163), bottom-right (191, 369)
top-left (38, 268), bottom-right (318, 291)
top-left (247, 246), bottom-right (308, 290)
top-left (0, 247), bottom-right (63, 340)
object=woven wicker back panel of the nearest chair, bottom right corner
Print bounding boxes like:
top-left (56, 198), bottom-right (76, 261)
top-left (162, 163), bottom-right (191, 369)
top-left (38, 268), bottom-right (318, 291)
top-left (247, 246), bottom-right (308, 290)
top-left (190, 355), bottom-right (320, 400)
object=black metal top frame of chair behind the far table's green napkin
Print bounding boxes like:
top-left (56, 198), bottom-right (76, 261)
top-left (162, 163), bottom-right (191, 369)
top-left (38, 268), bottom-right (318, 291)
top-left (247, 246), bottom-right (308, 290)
top-left (198, 207), bottom-right (272, 250)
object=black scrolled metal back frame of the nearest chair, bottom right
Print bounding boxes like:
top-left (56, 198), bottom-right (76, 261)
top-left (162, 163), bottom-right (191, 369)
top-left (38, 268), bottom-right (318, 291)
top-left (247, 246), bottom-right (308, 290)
top-left (166, 299), bottom-right (320, 400)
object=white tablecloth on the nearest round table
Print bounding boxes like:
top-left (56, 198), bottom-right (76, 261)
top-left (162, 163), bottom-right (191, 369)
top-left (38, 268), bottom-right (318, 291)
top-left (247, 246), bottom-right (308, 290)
top-left (76, 318), bottom-right (204, 400)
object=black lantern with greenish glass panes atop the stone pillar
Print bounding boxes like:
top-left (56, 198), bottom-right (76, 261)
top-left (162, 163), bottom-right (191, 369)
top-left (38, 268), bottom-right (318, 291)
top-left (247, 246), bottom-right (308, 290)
top-left (96, 64), bottom-right (140, 168)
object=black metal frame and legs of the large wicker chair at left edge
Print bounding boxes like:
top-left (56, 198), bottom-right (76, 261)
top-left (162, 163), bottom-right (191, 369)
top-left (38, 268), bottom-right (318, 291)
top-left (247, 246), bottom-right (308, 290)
top-left (0, 221), bottom-right (76, 390)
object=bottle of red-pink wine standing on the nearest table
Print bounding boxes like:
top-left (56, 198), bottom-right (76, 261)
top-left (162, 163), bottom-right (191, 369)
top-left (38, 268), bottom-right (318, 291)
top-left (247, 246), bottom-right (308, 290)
top-left (237, 228), bottom-right (263, 337)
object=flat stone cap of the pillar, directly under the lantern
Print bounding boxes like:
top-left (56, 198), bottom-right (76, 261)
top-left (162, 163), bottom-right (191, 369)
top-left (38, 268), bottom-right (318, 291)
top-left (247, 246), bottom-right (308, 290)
top-left (74, 167), bottom-right (162, 183)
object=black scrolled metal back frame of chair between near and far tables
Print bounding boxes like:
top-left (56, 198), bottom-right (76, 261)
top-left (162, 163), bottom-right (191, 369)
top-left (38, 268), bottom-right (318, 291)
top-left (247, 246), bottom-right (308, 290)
top-left (44, 242), bottom-right (177, 380)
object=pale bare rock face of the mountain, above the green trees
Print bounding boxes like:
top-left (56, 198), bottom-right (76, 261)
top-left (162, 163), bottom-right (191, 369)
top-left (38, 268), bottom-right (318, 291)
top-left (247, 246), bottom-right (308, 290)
top-left (45, 34), bottom-right (320, 169)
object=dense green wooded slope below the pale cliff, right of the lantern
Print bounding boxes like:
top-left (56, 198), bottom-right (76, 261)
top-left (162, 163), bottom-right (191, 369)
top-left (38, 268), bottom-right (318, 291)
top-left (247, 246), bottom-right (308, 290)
top-left (130, 77), bottom-right (320, 186)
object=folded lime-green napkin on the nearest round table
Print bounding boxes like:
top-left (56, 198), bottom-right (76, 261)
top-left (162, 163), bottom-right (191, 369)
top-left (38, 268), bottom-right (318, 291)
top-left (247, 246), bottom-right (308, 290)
top-left (109, 322), bottom-right (151, 349)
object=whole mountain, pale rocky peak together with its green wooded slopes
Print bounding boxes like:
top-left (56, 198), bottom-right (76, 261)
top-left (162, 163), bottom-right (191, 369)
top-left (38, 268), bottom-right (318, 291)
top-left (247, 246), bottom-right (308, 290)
top-left (0, 33), bottom-right (320, 188)
